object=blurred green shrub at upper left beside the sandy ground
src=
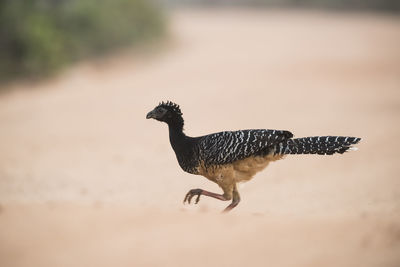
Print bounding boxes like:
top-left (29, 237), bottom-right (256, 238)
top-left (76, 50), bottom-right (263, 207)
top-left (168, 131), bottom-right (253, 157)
top-left (0, 0), bottom-right (163, 80)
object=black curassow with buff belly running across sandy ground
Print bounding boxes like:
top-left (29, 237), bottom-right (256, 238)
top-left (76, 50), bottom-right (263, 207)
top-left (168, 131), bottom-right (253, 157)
top-left (146, 101), bottom-right (361, 212)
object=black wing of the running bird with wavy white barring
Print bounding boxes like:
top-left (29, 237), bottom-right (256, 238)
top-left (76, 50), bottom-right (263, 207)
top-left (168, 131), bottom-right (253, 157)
top-left (199, 129), bottom-right (293, 165)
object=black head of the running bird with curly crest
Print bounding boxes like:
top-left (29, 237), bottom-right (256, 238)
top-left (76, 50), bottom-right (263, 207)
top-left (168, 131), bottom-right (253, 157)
top-left (146, 101), bottom-right (183, 127)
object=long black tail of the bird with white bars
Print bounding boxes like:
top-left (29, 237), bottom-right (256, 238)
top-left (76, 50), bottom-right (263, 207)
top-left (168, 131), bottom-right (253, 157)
top-left (275, 136), bottom-right (361, 155)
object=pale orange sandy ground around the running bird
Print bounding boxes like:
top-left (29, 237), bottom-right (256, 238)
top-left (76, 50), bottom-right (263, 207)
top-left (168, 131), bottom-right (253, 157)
top-left (0, 10), bottom-right (400, 267)
